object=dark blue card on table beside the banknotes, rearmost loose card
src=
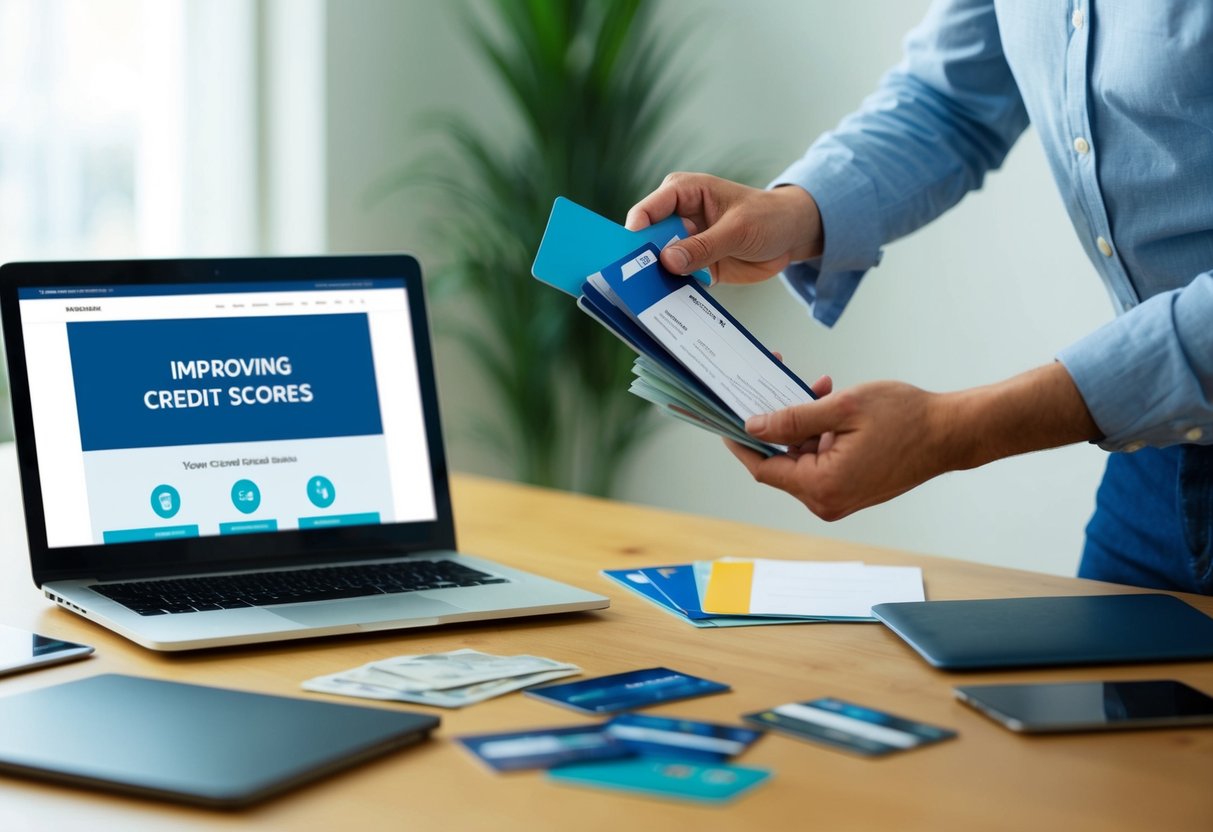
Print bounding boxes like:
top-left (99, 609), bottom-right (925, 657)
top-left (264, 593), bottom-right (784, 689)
top-left (524, 667), bottom-right (730, 714)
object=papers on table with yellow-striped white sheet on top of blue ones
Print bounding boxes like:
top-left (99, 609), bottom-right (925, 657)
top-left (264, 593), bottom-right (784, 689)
top-left (603, 558), bottom-right (926, 627)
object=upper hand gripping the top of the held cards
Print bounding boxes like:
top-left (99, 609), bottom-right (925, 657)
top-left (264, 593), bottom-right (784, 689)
top-left (627, 173), bottom-right (825, 283)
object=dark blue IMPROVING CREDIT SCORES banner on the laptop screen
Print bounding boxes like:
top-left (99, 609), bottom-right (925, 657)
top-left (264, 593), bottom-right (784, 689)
top-left (67, 314), bottom-right (383, 451)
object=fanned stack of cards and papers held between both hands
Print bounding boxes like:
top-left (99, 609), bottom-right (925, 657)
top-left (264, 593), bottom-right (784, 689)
top-left (533, 199), bottom-right (815, 456)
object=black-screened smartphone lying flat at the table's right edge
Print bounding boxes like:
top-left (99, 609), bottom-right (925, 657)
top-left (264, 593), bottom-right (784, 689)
top-left (953, 679), bottom-right (1213, 734)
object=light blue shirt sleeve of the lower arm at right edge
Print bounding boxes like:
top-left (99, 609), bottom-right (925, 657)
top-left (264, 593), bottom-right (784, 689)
top-left (1058, 272), bottom-right (1213, 451)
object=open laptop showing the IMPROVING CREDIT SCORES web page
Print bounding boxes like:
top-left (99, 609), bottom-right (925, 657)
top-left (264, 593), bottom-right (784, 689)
top-left (0, 255), bottom-right (609, 650)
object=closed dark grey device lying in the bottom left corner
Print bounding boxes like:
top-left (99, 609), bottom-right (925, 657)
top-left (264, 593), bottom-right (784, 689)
top-left (0, 674), bottom-right (438, 809)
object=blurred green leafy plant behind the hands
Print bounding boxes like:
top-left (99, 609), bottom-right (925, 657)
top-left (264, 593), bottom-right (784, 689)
top-left (386, 0), bottom-right (732, 495)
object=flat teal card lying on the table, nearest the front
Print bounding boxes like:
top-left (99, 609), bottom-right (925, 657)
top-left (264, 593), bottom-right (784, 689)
top-left (547, 757), bottom-right (770, 803)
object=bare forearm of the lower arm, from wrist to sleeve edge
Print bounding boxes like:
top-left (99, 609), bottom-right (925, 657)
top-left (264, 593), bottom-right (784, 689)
top-left (934, 361), bottom-right (1101, 471)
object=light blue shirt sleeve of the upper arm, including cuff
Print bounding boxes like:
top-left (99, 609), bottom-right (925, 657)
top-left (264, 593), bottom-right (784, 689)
top-left (771, 0), bottom-right (1027, 326)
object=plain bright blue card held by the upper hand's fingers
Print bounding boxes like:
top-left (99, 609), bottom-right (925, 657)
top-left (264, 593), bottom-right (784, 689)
top-left (531, 196), bottom-right (712, 297)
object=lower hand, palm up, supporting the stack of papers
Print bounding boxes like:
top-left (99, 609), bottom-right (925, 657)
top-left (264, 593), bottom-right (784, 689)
top-left (725, 377), bottom-right (958, 520)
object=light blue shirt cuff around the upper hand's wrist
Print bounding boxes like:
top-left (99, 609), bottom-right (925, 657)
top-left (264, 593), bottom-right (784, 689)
top-left (769, 147), bottom-right (882, 326)
